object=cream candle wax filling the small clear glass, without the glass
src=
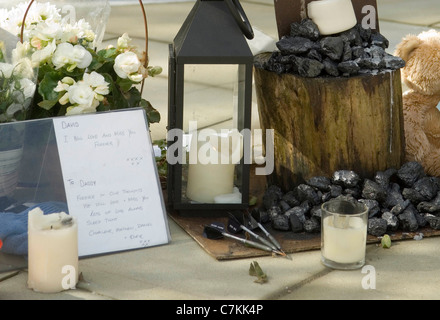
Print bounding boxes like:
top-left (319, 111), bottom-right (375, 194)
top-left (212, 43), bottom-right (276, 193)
top-left (322, 216), bottom-right (367, 264)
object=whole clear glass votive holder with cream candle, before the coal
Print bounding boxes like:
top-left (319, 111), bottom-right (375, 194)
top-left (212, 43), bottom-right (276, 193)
top-left (321, 199), bottom-right (368, 270)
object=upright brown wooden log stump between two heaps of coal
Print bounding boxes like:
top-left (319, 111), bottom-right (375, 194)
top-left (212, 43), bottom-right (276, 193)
top-left (254, 55), bottom-right (405, 190)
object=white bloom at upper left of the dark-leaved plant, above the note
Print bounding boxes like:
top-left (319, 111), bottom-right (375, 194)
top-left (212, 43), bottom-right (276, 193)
top-left (52, 43), bottom-right (93, 71)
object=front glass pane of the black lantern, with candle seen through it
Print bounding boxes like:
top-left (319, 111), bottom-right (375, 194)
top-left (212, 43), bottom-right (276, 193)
top-left (181, 64), bottom-right (244, 203)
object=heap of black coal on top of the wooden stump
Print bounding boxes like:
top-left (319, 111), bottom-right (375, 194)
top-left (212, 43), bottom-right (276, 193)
top-left (261, 19), bottom-right (405, 78)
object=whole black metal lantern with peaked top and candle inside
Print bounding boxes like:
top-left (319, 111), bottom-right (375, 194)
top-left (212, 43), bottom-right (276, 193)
top-left (167, 0), bottom-right (253, 216)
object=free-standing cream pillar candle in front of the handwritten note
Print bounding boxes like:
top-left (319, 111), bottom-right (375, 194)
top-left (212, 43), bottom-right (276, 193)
top-left (28, 208), bottom-right (78, 293)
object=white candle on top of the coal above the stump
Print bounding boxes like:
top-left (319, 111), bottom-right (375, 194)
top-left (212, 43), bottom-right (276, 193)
top-left (307, 0), bottom-right (357, 35)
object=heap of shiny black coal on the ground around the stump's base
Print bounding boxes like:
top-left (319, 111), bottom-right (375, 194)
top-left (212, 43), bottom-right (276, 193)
top-left (254, 162), bottom-right (440, 236)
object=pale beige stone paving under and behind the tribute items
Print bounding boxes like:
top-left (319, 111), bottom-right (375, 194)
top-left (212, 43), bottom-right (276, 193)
top-left (0, 0), bottom-right (440, 300)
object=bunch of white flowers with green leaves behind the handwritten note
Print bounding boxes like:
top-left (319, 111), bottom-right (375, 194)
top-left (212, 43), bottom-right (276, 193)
top-left (0, 1), bottom-right (162, 123)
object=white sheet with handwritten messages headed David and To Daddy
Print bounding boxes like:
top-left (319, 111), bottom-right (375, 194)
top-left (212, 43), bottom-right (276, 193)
top-left (54, 109), bottom-right (169, 256)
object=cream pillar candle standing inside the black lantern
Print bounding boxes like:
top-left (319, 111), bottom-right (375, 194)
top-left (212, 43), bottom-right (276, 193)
top-left (186, 129), bottom-right (243, 203)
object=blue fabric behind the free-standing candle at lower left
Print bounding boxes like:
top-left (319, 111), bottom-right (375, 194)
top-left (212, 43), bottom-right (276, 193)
top-left (0, 202), bottom-right (68, 255)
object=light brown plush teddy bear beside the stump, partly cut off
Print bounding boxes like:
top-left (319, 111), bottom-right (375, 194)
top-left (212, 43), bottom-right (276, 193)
top-left (395, 30), bottom-right (440, 176)
